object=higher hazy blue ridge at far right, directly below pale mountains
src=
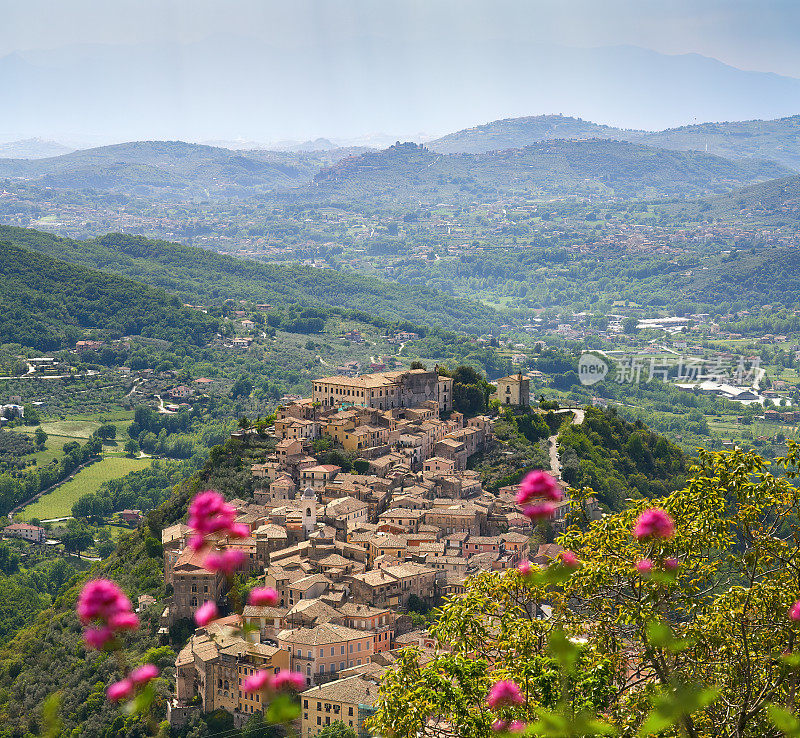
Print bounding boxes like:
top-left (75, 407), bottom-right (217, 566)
top-left (427, 115), bottom-right (800, 170)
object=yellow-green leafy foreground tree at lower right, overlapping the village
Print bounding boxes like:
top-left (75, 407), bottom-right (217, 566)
top-left (369, 441), bottom-right (800, 738)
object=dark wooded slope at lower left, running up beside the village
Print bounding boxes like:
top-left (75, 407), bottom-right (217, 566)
top-left (0, 441), bottom-right (264, 738)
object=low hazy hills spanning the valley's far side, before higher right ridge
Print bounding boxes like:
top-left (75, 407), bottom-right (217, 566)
top-left (0, 139), bottom-right (790, 202)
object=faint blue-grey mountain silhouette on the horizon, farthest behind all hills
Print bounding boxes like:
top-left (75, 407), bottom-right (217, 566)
top-left (0, 34), bottom-right (800, 141)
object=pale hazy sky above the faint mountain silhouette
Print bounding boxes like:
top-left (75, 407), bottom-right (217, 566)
top-left (0, 0), bottom-right (800, 77)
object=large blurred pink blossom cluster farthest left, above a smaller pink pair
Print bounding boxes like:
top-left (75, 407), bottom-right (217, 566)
top-left (75, 579), bottom-right (139, 650)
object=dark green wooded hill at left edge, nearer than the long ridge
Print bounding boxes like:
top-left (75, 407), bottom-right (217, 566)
top-left (0, 242), bottom-right (218, 350)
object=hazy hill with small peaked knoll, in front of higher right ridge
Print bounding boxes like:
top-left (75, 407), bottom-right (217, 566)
top-left (307, 139), bottom-right (788, 203)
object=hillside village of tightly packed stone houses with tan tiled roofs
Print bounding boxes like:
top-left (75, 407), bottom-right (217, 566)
top-left (162, 369), bottom-right (588, 738)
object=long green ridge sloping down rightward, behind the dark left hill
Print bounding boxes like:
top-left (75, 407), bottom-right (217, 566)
top-left (0, 226), bottom-right (505, 333)
